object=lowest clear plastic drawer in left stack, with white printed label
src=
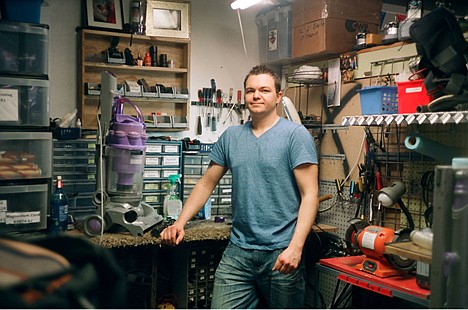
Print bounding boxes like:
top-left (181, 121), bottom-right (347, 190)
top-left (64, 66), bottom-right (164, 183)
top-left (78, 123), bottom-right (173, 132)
top-left (0, 184), bottom-right (48, 234)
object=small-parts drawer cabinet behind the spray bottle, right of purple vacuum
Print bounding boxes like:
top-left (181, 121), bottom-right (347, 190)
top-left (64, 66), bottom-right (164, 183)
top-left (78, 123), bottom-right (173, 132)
top-left (143, 139), bottom-right (182, 215)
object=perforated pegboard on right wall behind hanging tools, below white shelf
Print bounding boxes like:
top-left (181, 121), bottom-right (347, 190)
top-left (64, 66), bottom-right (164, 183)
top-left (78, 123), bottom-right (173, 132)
top-left (318, 118), bottom-right (468, 307)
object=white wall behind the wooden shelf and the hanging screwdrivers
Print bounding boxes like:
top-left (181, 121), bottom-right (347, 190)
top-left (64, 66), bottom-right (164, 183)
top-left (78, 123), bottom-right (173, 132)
top-left (41, 0), bottom-right (261, 142)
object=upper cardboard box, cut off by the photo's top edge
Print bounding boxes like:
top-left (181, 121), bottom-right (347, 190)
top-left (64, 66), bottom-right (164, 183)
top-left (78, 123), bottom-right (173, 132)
top-left (292, 0), bottom-right (382, 27)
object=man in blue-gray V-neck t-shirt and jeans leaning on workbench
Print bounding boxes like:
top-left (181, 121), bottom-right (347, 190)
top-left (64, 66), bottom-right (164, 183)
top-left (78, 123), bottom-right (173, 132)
top-left (161, 65), bottom-right (319, 308)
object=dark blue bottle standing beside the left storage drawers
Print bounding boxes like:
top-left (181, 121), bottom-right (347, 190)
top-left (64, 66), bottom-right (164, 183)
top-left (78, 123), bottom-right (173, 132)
top-left (49, 176), bottom-right (68, 234)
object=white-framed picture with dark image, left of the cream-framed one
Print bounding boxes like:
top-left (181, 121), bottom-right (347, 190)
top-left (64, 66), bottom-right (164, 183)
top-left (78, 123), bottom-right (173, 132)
top-left (83, 0), bottom-right (123, 31)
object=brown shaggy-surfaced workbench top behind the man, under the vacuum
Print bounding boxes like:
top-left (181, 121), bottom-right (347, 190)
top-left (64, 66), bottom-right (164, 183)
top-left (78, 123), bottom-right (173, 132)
top-left (84, 221), bottom-right (337, 248)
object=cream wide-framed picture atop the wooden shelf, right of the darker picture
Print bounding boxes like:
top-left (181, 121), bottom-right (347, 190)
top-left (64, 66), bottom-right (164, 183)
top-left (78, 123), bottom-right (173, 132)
top-left (146, 0), bottom-right (190, 39)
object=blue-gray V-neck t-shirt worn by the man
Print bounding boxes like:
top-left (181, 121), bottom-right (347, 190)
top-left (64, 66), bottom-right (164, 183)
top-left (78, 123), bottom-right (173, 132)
top-left (210, 118), bottom-right (318, 250)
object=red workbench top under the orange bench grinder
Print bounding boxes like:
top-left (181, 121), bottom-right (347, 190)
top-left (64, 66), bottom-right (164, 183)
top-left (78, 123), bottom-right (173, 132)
top-left (314, 255), bottom-right (430, 308)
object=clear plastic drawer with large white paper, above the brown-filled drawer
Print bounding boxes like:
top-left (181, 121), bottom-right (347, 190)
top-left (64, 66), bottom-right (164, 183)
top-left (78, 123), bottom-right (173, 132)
top-left (0, 77), bottom-right (50, 127)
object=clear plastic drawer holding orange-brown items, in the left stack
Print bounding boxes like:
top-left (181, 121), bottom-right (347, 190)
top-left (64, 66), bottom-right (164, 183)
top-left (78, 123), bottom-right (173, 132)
top-left (0, 132), bottom-right (52, 180)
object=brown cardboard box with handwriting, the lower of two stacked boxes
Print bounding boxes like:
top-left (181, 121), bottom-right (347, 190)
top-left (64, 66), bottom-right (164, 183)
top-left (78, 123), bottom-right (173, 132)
top-left (291, 18), bottom-right (378, 57)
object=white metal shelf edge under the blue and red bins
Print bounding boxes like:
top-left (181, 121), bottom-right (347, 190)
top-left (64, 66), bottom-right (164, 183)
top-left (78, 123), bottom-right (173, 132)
top-left (341, 111), bottom-right (468, 126)
